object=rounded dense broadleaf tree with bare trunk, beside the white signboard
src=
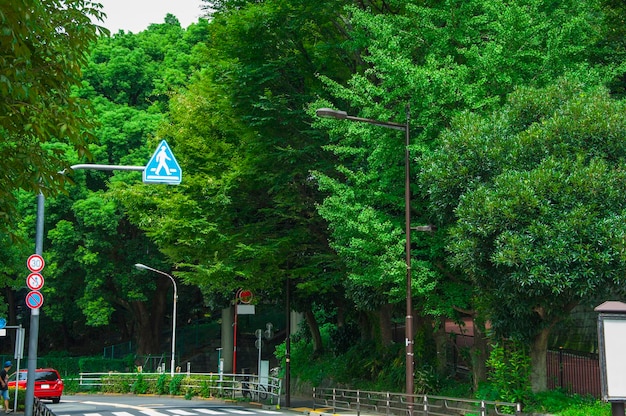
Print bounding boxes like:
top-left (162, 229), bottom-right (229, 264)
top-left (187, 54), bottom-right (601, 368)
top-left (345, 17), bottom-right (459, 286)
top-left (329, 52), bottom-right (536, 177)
top-left (422, 80), bottom-right (626, 391)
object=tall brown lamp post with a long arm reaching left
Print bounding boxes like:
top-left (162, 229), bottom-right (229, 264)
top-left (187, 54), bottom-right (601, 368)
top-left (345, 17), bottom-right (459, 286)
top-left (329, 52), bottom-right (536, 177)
top-left (315, 106), bottom-right (414, 415)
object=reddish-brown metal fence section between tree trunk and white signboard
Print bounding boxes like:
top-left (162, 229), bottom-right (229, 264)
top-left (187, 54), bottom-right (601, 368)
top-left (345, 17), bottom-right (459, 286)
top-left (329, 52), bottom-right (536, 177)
top-left (546, 349), bottom-right (602, 398)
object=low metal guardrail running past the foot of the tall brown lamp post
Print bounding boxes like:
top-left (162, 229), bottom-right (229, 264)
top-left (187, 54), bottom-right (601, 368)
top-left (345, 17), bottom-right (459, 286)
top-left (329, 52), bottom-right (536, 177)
top-left (313, 388), bottom-right (522, 416)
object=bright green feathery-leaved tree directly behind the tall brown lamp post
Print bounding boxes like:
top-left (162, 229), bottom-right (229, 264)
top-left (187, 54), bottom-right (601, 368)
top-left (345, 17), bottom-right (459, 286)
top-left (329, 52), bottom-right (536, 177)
top-left (315, 0), bottom-right (615, 384)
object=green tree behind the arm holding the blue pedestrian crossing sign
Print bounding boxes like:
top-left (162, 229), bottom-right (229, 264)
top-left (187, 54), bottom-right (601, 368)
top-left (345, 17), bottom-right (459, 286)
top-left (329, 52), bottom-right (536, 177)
top-left (43, 16), bottom-right (207, 354)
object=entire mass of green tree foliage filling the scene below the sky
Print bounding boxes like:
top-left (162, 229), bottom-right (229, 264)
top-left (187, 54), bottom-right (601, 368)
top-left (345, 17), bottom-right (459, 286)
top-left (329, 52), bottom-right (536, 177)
top-left (0, 0), bottom-right (626, 406)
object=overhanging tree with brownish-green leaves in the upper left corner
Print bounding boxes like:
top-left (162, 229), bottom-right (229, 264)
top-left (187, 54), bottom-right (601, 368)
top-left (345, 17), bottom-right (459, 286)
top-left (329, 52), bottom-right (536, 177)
top-left (0, 0), bottom-right (105, 229)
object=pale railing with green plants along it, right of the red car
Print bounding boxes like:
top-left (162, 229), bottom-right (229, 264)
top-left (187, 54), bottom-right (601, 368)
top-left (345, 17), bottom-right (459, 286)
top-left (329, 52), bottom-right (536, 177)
top-left (68, 372), bottom-right (282, 407)
